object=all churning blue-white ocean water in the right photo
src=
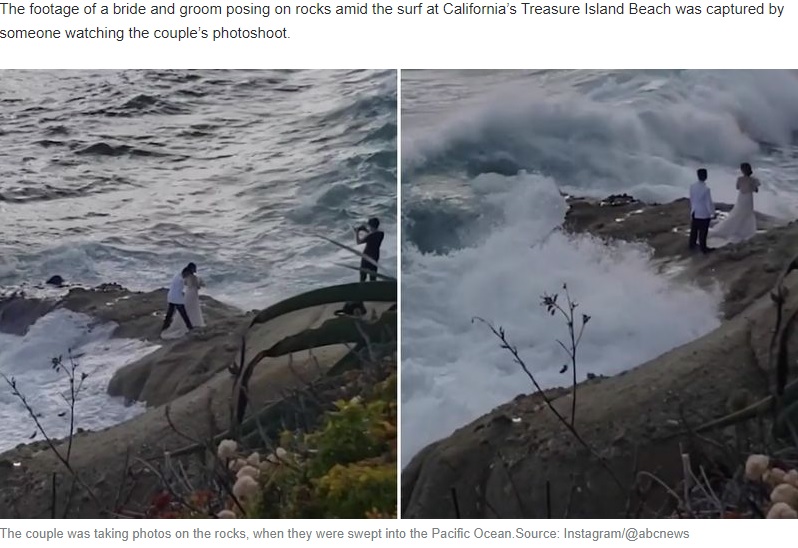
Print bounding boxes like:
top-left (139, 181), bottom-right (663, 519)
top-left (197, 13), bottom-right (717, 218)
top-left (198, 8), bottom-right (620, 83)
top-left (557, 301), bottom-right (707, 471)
top-left (402, 71), bottom-right (798, 465)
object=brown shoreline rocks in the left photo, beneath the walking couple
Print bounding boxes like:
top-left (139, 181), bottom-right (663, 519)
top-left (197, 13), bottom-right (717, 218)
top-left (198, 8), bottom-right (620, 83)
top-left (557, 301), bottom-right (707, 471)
top-left (0, 284), bottom-right (395, 518)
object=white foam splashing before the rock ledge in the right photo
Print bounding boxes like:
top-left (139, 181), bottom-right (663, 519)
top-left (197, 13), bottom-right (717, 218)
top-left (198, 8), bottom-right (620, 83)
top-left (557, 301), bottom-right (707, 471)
top-left (402, 173), bottom-right (720, 466)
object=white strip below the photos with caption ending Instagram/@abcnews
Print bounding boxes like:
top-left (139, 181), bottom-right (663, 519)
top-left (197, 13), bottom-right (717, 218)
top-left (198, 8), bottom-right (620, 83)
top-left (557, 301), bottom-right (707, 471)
top-left (0, 520), bottom-right (795, 548)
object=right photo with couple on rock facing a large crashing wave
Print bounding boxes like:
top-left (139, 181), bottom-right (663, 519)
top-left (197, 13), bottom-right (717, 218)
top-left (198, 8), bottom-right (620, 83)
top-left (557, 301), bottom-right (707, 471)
top-left (401, 70), bottom-right (798, 520)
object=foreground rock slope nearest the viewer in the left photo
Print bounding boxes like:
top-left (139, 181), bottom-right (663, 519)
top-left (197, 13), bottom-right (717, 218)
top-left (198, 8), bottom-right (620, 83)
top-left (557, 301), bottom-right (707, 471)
top-left (0, 347), bottom-right (356, 519)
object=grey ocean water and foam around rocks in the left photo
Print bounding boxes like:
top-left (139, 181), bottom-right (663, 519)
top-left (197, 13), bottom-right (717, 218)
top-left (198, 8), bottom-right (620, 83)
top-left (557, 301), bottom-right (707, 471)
top-left (0, 70), bottom-right (397, 448)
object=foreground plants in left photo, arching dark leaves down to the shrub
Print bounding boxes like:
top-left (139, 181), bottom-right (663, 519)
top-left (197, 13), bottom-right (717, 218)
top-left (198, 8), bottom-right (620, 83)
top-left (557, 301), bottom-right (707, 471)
top-left (130, 236), bottom-right (398, 519)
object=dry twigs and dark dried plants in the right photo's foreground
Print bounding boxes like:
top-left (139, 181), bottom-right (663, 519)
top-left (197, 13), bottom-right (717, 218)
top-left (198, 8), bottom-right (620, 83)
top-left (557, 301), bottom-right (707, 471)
top-left (468, 258), bottom-right (798, 519)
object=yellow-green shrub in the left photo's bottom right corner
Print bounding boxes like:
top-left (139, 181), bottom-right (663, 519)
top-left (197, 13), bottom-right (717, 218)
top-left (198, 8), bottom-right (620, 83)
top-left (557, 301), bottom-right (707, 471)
top-left (248, 371), bottom-right (397, 519)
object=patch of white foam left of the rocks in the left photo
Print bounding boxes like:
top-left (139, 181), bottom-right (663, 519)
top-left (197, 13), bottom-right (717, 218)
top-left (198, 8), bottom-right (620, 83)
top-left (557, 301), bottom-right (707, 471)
top-left (0, 309), bottom-right (158, 451)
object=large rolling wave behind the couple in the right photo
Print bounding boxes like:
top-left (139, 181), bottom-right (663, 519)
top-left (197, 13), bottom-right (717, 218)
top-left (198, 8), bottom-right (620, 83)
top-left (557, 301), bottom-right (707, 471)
top-left (402, 70), bottom-right (798, 218)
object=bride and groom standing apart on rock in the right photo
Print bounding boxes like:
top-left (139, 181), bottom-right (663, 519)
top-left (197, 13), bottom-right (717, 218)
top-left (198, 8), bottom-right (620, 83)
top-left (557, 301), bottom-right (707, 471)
top-left (690, 162), bottom-right (761, 253)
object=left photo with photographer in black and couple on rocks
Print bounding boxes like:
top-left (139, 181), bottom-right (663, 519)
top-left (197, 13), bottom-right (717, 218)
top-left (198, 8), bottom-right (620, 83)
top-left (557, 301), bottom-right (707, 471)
top-left (0, 70), bottom-right (398, 520)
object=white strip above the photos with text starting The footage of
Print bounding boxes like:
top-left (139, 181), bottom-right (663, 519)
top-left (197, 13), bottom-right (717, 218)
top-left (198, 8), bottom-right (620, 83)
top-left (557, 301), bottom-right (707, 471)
top-left (0, 0), bottom-right (798, 68)
